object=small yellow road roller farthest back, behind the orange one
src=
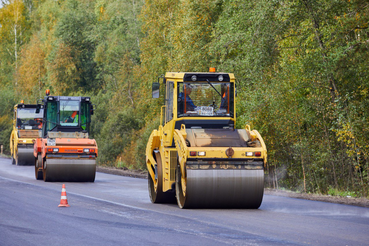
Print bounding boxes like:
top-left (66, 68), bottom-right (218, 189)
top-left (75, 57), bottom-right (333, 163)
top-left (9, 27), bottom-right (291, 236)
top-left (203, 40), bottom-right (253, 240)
top-left (10, 100), bottom-right (43, 165)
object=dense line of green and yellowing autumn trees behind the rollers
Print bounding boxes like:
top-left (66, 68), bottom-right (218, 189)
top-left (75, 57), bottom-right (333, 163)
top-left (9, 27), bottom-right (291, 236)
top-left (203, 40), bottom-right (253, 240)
top-left (0, 0), bottom-right (369, 197)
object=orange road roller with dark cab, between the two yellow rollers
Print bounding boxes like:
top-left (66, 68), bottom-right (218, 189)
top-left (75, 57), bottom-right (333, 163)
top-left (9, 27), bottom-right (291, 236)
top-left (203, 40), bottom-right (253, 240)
top-left (33, 92), bottom-right (98, 182)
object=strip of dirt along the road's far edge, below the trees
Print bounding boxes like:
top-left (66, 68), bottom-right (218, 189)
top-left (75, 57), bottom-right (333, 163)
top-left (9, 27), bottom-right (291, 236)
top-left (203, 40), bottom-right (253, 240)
top-left (96, 166), bottom-right (369, 208)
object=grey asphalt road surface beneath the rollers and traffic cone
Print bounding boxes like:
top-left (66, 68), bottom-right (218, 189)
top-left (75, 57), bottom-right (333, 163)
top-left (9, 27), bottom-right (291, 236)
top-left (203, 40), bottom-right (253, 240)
top-left (0, 158), bottom-right (369, 246)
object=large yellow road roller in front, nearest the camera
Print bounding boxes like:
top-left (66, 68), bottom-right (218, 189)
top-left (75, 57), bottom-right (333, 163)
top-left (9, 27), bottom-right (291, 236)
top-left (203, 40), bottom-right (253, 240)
top-left (146, 69), bottom-right (267, 208)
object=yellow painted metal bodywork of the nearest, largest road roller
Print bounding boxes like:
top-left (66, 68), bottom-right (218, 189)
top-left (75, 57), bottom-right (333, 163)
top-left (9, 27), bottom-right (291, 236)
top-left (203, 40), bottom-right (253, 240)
top-left (146, 72), bottom-right (267, 194)
